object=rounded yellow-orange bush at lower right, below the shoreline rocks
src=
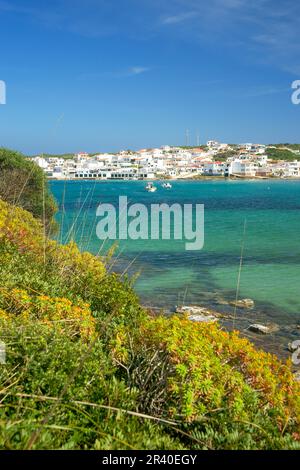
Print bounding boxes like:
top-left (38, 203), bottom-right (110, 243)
top-left (112, 316), bottom-right (300, 449)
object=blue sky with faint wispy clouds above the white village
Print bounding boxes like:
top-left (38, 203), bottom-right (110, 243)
top-left (0, 0), bottom-right (300, 154)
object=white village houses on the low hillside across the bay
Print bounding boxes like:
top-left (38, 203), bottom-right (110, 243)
top-left (30, 140), bottom-right (300, 180)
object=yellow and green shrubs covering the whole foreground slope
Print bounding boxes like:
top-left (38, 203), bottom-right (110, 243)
top-left (0, 196), bottom-right (300, 449)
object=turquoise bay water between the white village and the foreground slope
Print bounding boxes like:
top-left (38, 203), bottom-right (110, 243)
top-left (51, 180), bottom-right (300, 356)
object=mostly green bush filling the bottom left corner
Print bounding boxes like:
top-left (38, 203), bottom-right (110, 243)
top-left (0, 317), bottom-right (183, 450)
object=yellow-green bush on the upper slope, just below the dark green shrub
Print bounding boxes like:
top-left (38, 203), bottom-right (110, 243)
top-left (0, 201), bottom-right (142, 322)
